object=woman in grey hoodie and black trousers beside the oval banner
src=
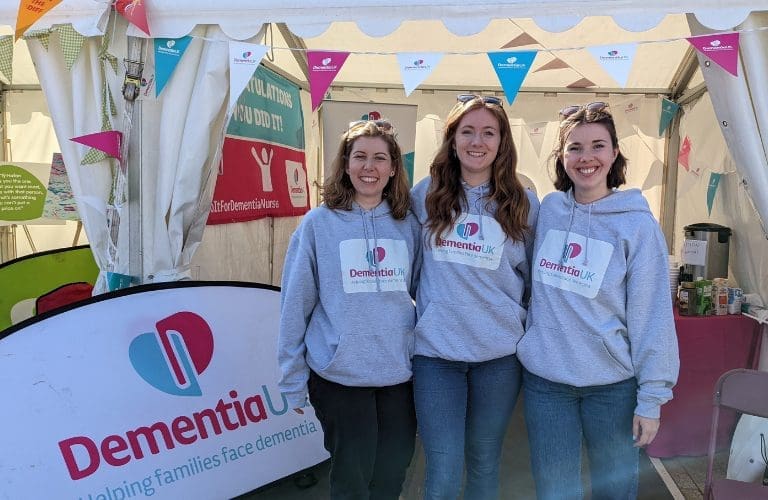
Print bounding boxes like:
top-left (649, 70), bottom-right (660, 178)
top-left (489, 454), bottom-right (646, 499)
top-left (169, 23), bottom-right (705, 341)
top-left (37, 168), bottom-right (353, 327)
top-left (278, 120), bottom-right (421, 500)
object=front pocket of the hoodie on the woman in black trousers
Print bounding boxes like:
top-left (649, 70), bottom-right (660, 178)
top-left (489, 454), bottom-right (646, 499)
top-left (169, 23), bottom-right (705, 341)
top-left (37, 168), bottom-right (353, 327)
top-left (321, 324), bottom-right (413, 387)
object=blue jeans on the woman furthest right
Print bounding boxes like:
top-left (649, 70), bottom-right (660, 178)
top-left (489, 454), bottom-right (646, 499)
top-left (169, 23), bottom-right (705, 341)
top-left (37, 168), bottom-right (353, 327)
top-left (523, 370), bottom-right (639, 500)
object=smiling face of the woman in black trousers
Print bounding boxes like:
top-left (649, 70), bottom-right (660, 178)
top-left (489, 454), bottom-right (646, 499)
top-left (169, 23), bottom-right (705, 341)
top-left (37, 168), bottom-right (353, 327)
top-left (345, 136), bottom-right (394, 209)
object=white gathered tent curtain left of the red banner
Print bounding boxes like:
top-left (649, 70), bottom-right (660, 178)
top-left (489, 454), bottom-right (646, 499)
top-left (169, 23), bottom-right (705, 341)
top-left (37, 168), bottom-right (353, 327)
top-left (29, 21), bottom-right (229, 293)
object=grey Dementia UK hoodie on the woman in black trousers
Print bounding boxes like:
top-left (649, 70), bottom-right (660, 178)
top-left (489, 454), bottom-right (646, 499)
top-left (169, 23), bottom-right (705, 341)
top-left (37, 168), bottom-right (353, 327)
top-left (278, 200), bottom-right (421, 408)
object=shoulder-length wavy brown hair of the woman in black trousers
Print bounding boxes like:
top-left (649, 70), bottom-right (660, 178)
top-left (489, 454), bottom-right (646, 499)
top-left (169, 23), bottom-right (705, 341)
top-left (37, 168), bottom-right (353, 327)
top-left (321, 120), bottom-right (411, 219)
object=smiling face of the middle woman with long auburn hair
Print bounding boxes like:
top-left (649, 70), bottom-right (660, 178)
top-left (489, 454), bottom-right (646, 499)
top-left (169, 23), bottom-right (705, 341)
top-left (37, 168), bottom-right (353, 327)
top-left (453, 108), bottom-right (501, 186)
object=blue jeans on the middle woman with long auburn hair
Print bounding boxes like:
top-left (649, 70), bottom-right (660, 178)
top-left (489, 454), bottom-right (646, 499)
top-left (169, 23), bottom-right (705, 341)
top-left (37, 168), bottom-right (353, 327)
top-left (413, 354), bottom-right (522, 500)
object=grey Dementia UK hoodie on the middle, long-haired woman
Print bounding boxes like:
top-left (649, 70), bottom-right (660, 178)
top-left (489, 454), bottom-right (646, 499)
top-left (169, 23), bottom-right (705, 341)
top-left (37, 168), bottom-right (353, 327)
top-left (411, 178), bottom-right (539, 362)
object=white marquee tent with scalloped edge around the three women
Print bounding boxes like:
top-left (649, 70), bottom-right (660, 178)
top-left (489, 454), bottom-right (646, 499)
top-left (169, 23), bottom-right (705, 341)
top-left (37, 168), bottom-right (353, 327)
top-left (0, 0), bottom-right (768, 488)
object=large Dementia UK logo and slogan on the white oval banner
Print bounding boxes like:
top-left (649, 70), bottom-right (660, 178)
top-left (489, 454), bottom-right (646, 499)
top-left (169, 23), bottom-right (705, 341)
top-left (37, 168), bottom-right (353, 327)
top-left (58, 311), bottom-right (300, 480)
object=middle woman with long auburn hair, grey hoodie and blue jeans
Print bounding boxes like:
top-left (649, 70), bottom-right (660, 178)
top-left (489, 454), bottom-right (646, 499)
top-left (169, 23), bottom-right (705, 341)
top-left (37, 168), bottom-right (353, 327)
top-left (411, 95), bottom-right (539, 499)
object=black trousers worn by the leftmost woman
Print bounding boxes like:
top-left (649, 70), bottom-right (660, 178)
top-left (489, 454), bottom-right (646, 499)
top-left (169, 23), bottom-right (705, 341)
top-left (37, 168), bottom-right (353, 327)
top-left (308, 372), bottom-right (416, 500)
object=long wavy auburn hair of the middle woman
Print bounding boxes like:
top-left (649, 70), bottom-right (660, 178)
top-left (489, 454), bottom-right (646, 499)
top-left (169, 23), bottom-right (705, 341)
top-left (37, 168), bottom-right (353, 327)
top-left (426, 97), bottom-right (530, 241)
